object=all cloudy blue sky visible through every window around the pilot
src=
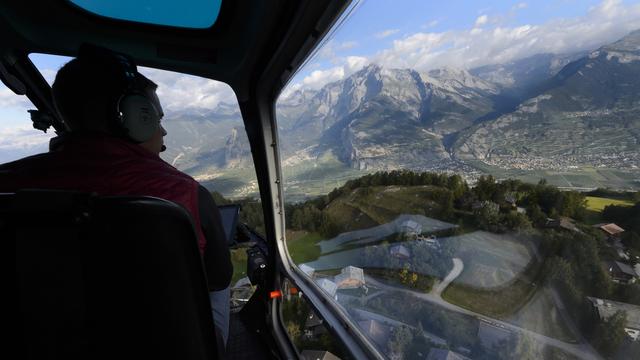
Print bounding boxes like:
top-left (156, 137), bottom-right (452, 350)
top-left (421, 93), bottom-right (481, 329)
top-left (0, 0), bottom-right (640, 161)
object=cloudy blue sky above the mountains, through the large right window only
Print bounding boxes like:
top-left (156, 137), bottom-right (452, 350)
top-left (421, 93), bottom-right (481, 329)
top-left (291, 0), bottom-right (640, 87)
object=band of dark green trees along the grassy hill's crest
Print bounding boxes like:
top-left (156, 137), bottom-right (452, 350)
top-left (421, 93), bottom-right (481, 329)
top-left (285, 171), bottom-right (586, 238)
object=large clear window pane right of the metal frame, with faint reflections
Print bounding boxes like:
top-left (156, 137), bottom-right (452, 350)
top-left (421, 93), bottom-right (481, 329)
top-left (276, 1), bottom-right (640, 359)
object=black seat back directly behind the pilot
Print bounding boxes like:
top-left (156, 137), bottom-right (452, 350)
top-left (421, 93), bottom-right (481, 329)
top-left (0, 191), bottom-right (217, 359)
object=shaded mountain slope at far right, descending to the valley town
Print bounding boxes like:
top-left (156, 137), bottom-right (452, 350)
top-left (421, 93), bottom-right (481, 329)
top-left (455, 32), bottom-right (640, 168)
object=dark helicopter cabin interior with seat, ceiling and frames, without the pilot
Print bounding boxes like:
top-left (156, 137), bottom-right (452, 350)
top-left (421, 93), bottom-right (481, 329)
top-left (0, 1), bottom-right (370, 359)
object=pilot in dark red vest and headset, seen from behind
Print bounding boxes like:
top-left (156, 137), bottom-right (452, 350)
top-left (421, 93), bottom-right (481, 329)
top-left (0, 45), bottom-right (233, 344)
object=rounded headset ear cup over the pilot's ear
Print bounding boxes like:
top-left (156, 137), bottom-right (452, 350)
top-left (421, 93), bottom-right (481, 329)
top-left (118, 94), bottom-right (160, 143)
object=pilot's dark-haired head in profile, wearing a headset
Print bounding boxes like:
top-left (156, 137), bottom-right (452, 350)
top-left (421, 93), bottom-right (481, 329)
top-left (52, 46), bottom-right (167, 153)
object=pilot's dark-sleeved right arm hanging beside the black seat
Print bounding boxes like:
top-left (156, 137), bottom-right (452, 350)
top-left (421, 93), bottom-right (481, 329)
top-left (198, 185), bottom-right (233, 291)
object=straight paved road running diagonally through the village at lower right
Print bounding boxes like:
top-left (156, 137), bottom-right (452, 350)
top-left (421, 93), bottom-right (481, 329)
top-left (365, 275), bottom-right (602, 360)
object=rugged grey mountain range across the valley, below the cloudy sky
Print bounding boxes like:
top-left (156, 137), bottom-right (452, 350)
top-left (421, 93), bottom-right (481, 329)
top-left (163, 31), bottom-right (640, 188)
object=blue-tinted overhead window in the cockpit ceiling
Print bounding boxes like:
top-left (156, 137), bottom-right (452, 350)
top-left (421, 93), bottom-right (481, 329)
top-left (69, 0), bottom-right (222, 29)
